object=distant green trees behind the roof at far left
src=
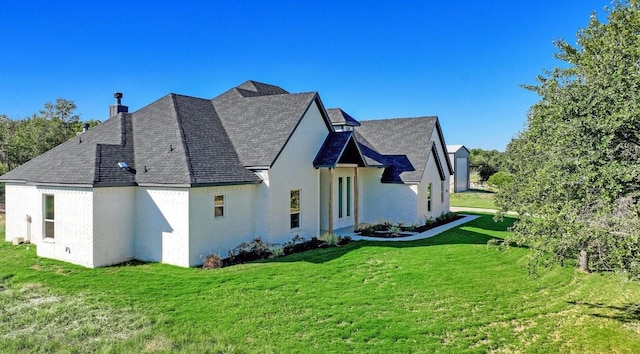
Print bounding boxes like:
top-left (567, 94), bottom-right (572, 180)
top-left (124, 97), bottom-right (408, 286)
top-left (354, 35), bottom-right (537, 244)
top-left (0, 98), bottom-right (99, 174)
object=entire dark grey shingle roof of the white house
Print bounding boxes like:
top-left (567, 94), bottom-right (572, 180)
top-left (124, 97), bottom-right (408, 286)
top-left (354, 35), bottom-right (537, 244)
top-left (0, 81), bottom-right (450, 186)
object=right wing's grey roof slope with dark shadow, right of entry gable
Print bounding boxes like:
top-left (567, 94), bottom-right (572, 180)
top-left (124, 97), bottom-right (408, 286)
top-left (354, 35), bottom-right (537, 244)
top-left (355, 117), bottom-right (438, 183)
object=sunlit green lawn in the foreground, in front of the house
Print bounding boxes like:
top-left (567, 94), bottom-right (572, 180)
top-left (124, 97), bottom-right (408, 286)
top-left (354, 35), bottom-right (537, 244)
top-left (0, 215), bottom-right (640, 353)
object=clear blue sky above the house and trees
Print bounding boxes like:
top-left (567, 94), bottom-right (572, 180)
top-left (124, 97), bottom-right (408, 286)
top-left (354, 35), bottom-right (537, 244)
top-left (0, 0), bottom-right (610, 151)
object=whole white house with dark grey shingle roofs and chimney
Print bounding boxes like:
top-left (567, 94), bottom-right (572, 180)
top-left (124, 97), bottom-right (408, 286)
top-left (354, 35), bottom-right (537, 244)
top-left (0, 81), bottom-right (452, 267)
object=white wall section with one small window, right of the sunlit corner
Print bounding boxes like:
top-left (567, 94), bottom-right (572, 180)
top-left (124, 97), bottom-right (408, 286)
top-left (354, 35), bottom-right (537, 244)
top-left (189, 184), bottom-right (261, 266)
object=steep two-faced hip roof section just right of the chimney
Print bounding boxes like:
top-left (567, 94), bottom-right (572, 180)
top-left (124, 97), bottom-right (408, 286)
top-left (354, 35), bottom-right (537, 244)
top-left (133, 94), bottom-right (260, 185)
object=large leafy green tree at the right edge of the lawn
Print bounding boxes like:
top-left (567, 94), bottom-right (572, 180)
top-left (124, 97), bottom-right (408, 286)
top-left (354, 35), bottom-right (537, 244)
top-left (496, 0), bottom-right (640, 279)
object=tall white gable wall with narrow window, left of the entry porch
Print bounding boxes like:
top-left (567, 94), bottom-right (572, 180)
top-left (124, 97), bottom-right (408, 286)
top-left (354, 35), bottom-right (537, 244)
top-left (260, 103), bottom-right (329, 243)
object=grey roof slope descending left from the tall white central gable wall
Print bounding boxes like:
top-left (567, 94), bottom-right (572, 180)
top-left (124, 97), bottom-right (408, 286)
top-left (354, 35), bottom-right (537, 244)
top-left (212, 84), bottom-right (329, 168)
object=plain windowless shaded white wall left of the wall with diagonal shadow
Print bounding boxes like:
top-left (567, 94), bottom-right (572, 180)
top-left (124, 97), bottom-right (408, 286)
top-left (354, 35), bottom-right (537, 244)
top-left (93, 187), bottom-right (136, 267)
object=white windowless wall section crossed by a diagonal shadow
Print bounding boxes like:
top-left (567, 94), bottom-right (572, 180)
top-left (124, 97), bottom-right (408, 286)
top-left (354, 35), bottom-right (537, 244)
top-left (134, 187), bottom-right (189, 267)
